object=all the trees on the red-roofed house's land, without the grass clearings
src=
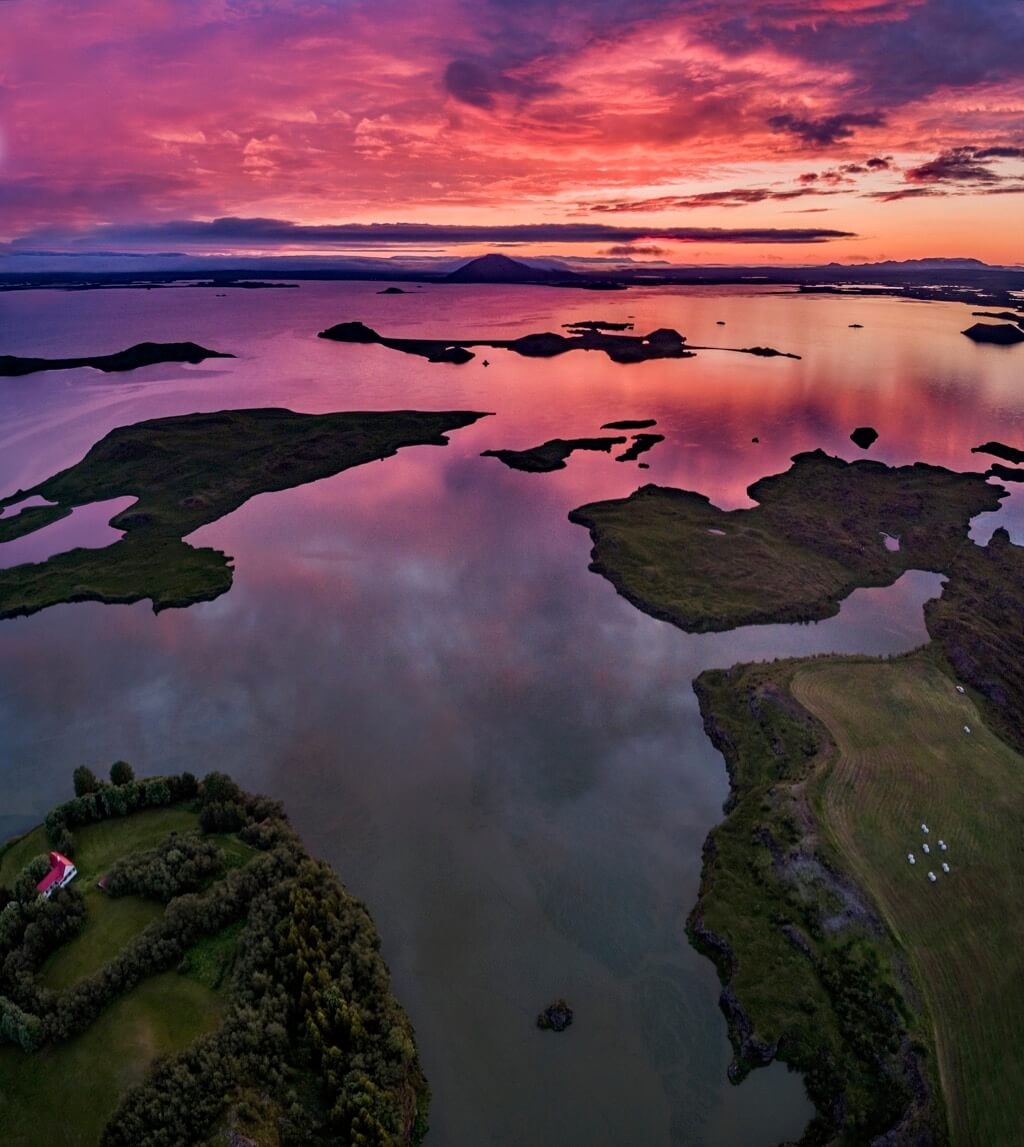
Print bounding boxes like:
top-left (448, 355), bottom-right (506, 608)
top-left (0, 773), bottom-right (429, 1147)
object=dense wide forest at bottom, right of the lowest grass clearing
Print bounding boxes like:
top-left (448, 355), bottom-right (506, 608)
top-left (103, 857), bottom-right (429, 1147)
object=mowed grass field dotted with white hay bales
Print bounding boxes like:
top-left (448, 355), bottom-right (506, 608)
top-left (792, 655), bottom-right (1024, 1147)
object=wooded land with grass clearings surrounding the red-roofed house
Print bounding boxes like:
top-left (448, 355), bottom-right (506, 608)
top-left (0, 763), bottom-right (429, 1147)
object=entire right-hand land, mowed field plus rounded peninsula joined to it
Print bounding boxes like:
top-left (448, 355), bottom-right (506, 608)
top-left (570, 452), bottom-right (1024, 1147)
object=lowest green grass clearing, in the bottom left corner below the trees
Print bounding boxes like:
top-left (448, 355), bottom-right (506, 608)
top-left (0, 972), bottom-right (222, 1147)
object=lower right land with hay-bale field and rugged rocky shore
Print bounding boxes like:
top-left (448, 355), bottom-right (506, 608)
top-left (689, 650), bottom-right (1024, 1147)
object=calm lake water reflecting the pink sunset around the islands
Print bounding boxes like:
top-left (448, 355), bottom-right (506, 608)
top-left (0, 283), bottom-right (1024, 1147)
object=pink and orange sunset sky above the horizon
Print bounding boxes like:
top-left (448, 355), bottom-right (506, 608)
top-left (0, 0), bottom-right (1024, 263)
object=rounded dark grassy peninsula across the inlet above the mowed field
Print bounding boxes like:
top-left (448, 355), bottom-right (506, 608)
top-left (569, 451), bottom-right (1006, 633)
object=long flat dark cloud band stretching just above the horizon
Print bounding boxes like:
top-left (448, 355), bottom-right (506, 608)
top-left (8, 217), bottom-right (854, 253)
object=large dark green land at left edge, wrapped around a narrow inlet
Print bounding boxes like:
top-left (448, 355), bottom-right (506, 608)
top-left (0, 408), bottom-right (484, 618)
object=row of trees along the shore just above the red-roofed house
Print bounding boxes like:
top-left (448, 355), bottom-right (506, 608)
top-left (44, 762), bottom-right (198, 857)
